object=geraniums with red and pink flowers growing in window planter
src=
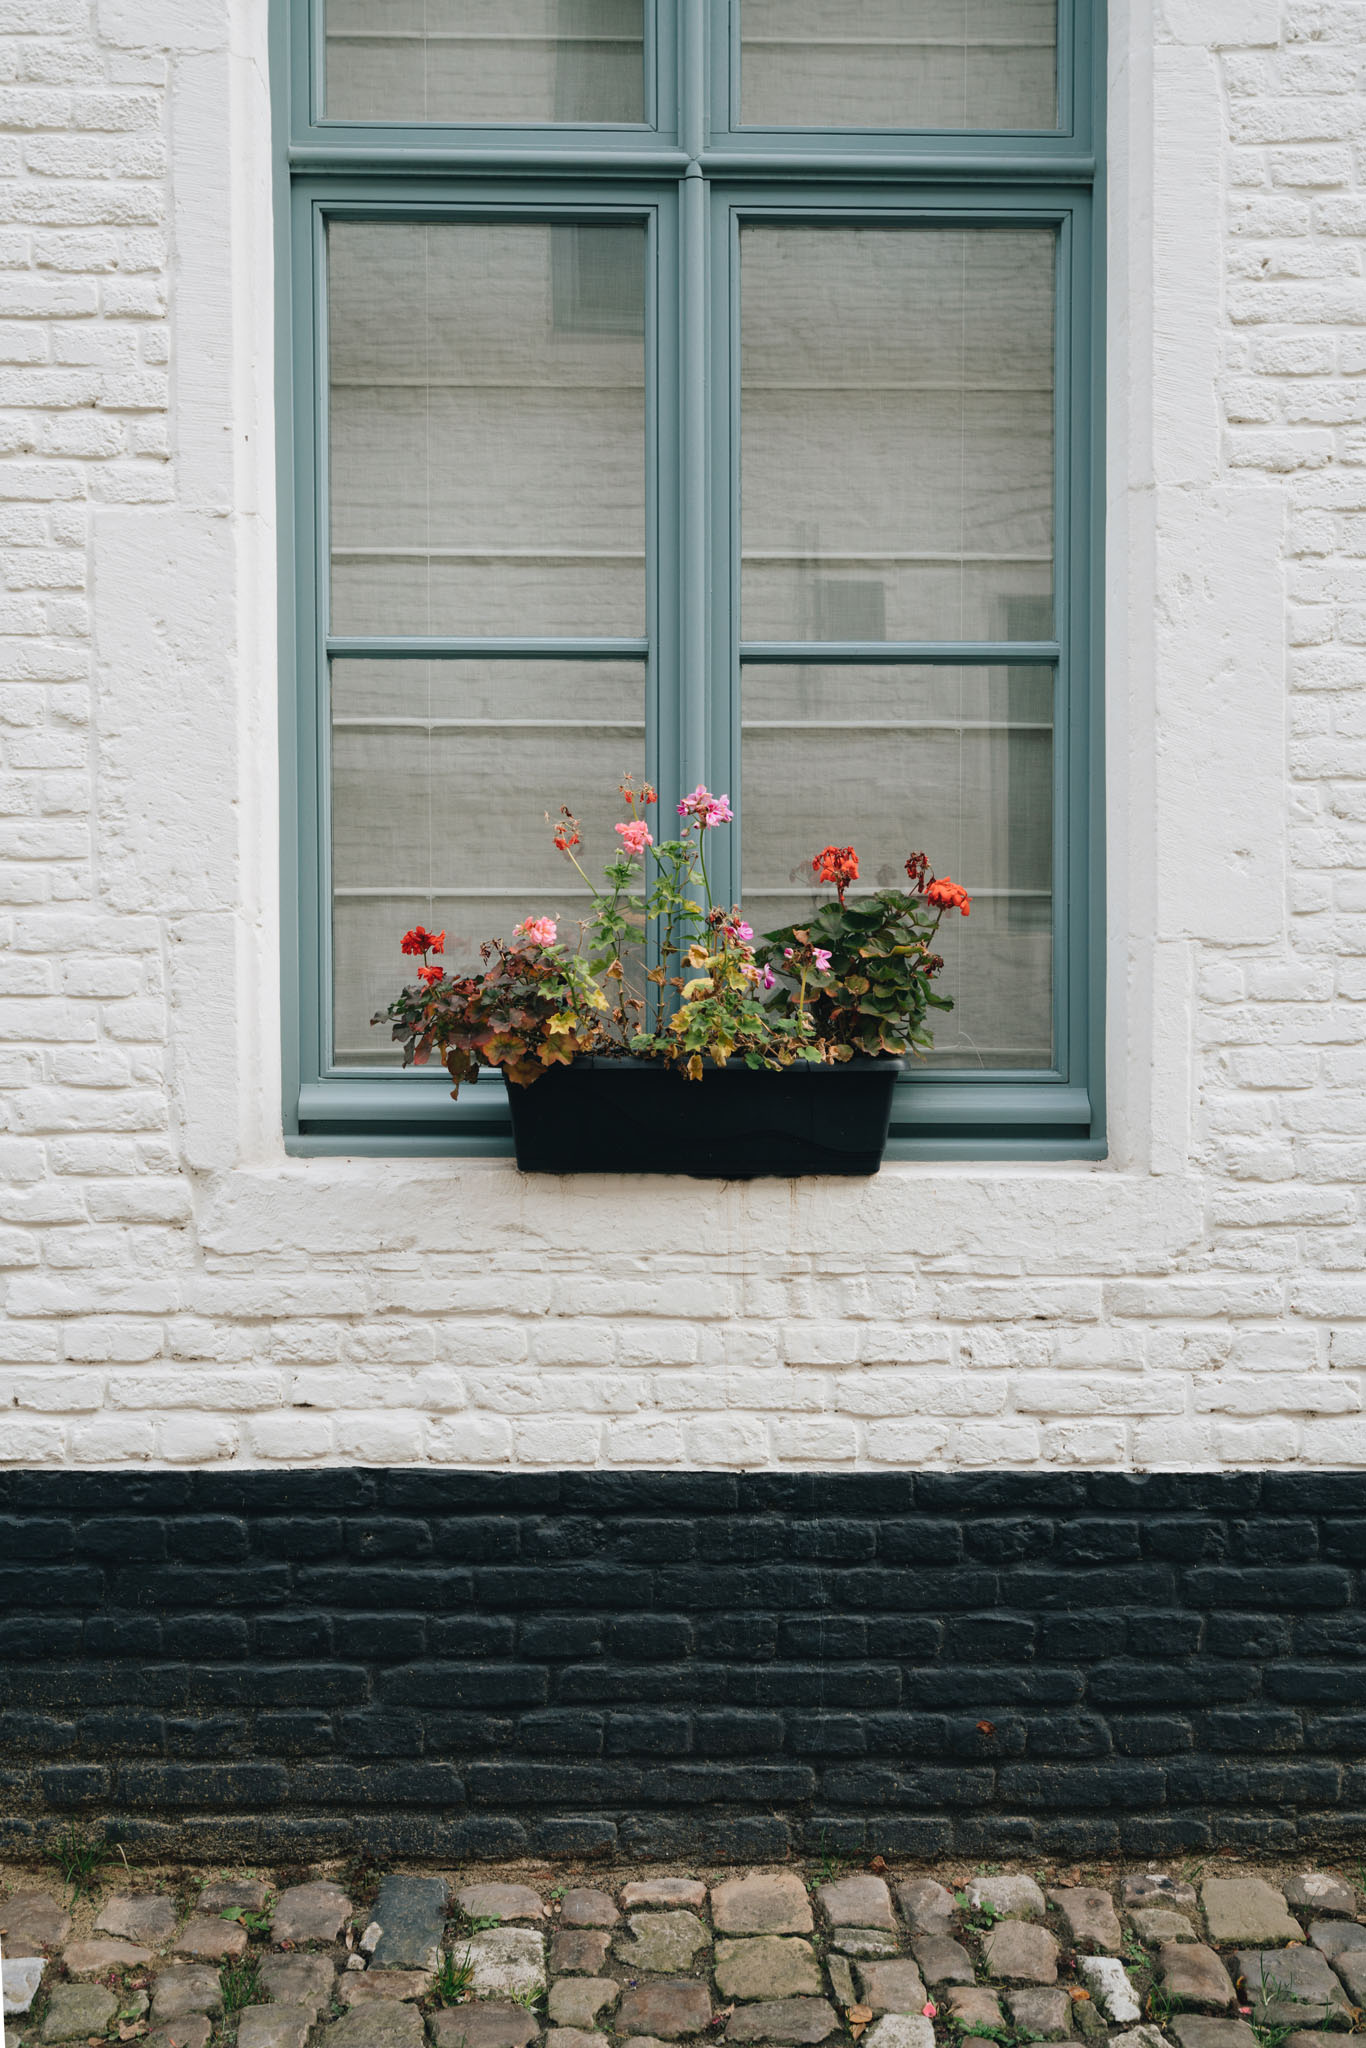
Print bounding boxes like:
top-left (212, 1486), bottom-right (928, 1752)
top-left (375, 778), bottom-right (971, 1092)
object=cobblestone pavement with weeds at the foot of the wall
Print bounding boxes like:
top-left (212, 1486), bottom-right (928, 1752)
top-left (0, 1858), bottom-right (1366, 2048)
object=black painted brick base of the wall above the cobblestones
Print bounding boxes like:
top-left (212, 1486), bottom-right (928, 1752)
top-left (0, 1470), bottom-right (1366, 1860)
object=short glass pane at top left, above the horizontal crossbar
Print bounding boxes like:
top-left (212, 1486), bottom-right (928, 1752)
top-left (328, 0), bottom-right (645, 123)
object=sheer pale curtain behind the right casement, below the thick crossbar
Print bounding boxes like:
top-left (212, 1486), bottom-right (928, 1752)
top-left (741, 227), bottom-right (1055, 1067)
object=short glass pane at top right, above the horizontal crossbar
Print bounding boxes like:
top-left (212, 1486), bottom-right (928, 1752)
top-left (739, 0), bottom-right (1057, 129)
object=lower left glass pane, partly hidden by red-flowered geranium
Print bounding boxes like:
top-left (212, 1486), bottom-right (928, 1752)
top-left (332, 662), bottom-right (645, 1067)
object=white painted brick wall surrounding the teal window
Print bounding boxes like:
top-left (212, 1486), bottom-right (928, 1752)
top-left (0, 0), bottom-right (1366, 1466)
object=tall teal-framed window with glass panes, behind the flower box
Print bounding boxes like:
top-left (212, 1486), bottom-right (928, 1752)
top-left (276, 0), bottom-right (1104, 1157)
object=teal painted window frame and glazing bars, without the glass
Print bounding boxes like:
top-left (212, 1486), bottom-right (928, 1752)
top-left (272, 0), bottom-right (1106, 1159)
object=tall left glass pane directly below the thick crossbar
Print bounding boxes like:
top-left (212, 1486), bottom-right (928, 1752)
top-left (328, 221), bottom-right (645, 635)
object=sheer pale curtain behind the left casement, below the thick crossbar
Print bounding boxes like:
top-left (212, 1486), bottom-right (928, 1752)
top-left (330, 221), bottom-right (645, 1065)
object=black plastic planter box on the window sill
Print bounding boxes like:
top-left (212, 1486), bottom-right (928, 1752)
top-left (508, 1059), bottom-right (903, 1180)
